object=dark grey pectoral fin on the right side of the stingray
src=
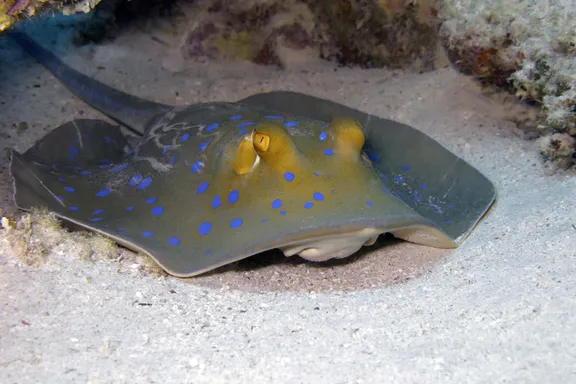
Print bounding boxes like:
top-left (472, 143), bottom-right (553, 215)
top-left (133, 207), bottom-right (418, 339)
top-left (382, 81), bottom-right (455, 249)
top-left (240, 91), bottom-right (496, 244)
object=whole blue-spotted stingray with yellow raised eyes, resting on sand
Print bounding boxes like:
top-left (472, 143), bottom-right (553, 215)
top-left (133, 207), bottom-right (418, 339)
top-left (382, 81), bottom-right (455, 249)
top-left (9, 31), bottom-right (496, 277)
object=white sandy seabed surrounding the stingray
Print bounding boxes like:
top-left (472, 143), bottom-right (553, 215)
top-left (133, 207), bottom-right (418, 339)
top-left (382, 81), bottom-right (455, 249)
top-left (0, 21), bottom-right (576, 383)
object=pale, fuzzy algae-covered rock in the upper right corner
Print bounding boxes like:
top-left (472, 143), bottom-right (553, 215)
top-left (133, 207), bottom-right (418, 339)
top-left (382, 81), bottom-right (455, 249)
top-left (440, 0), bottom-right (576, 168)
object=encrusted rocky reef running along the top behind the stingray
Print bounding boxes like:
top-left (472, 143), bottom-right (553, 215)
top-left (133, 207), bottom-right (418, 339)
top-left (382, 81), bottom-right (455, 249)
top-left (0, 0), bottom-right (576, 168)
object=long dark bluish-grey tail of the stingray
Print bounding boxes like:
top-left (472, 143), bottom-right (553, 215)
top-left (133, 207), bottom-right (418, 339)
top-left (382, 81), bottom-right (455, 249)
top-left (6, 30), bottom-right (170, 134)
